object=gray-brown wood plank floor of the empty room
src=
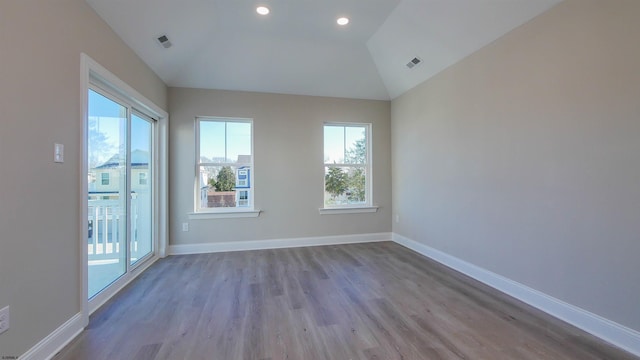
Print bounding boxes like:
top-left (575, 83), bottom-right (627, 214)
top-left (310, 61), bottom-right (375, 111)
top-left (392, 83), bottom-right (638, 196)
top-left (55, 242), bottom-right (636, 360)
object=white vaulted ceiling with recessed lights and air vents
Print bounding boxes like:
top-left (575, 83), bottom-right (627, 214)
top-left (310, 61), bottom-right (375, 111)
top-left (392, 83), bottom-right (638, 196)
top-left (86, 0), bottom-right (561, 100)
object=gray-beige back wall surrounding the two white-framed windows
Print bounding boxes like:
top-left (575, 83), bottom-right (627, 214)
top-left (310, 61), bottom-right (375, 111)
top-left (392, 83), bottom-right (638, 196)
top-left (169, 88), bottom-right (391, 245)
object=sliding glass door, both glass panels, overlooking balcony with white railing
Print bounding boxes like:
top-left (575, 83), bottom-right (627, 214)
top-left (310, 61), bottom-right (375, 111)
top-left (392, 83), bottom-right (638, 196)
top-left (87, 89), bottom-right (154, 299)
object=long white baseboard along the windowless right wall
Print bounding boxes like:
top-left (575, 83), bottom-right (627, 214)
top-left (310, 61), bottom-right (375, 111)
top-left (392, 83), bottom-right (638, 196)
top-left (392, 233), bottom-right (640, 356)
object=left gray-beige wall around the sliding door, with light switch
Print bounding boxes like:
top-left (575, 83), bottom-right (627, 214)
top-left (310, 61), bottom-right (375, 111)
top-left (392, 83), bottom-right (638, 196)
top-left (0, 0), bottom-right (167, 356)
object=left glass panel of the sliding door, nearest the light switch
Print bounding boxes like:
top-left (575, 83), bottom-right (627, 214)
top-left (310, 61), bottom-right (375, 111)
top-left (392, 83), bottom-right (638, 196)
top-left (86, 90), bottom-right (129, 299)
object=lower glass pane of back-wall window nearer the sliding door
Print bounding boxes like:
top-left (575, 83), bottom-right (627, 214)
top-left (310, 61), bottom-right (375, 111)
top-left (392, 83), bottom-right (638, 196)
top-left (198, 165), bottom-right (252, 209)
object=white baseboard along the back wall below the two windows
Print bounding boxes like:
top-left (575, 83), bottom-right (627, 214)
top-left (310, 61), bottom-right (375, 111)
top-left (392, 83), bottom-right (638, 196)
top-left (169, 233), bottom-right (391, 255)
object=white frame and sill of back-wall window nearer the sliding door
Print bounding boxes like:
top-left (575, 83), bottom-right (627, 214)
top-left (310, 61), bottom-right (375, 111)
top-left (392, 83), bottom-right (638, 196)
top-left (189, 116), bottom-right (260, 220)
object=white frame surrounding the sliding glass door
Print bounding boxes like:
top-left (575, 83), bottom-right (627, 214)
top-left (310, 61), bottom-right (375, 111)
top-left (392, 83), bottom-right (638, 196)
top-left (79, 54), bottom-right (169, 327)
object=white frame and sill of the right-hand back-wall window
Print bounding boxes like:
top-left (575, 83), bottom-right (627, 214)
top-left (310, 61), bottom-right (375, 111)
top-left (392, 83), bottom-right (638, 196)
top-left (318, 121), bottom-right (378, 215)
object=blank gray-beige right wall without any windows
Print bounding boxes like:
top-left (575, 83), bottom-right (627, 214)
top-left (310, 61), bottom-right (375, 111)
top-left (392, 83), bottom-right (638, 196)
top-left (392, 0), bottom-right (640, 330)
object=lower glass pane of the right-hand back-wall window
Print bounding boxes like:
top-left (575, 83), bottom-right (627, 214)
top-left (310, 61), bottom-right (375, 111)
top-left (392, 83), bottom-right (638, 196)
top-left (324, 166), bottom-right (367, 206)
